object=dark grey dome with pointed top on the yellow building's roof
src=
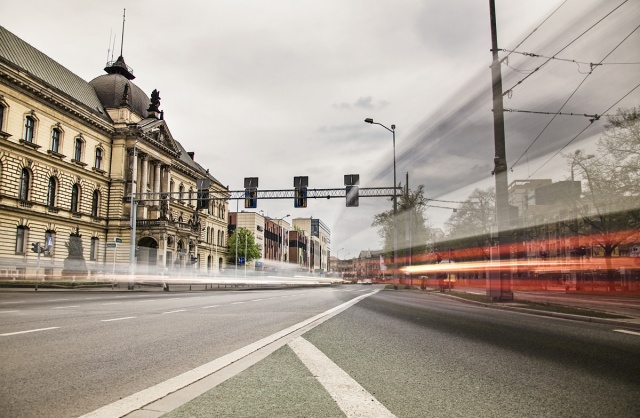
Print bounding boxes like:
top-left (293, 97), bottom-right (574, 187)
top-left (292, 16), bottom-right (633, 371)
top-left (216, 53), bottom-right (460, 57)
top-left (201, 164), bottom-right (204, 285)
top-left (89, 57), bottom-right (151, 119)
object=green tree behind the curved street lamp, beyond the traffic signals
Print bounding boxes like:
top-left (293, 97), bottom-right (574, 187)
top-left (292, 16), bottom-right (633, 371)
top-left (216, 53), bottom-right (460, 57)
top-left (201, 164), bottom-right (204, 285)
top-left (371, 185), bottom-right (431, 257)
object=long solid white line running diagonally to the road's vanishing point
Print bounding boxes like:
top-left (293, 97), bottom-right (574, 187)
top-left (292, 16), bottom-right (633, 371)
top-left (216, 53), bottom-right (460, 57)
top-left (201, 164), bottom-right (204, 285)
top-left (80, 290), bottom-right (378, 418)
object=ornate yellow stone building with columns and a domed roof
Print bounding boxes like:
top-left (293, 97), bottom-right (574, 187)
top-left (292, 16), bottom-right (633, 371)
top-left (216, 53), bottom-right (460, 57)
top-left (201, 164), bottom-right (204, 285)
top-left (0, 27), bottom-right (228, 277)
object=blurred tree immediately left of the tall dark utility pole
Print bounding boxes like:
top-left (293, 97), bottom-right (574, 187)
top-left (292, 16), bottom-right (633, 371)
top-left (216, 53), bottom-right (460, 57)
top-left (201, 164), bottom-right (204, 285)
top-left (440, 187), bottom-right (496, 260)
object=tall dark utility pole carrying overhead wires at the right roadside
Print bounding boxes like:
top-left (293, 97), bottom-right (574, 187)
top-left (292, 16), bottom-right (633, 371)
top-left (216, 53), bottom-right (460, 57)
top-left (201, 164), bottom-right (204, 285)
top-left (487, 0), bottom-right (513, 300)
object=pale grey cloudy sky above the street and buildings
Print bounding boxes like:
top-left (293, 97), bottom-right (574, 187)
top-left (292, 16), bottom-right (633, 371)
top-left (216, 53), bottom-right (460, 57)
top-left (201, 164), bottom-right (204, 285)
top-left (0, 0), bottom-right (640, 258)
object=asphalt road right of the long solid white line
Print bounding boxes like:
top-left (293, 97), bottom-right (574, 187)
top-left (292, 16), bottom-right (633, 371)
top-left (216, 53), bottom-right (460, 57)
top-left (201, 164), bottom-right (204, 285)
top-left (167, 291), bottom-right (640, 418)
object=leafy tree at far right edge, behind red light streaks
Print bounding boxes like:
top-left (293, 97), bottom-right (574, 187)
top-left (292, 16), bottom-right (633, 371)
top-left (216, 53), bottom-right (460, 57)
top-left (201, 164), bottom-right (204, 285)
top-left (565, 108), bottom-right (640, 291)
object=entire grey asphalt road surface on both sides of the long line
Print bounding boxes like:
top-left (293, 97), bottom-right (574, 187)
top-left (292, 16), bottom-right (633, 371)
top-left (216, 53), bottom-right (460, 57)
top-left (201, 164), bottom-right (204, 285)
top-left (0, 286), bottom-right (640, 417)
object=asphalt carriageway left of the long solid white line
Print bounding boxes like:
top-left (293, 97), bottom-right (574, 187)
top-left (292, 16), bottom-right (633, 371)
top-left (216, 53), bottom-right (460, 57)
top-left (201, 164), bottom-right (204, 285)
top-left (0, 287), bottom-right (370, 417)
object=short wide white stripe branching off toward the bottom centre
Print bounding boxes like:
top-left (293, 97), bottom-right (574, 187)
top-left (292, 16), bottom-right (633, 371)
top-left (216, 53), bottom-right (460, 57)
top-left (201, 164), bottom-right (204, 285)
top-left (289, 337), bottom-right (395, 417)
